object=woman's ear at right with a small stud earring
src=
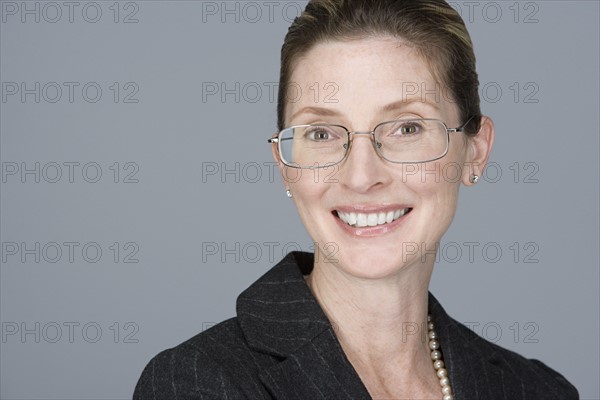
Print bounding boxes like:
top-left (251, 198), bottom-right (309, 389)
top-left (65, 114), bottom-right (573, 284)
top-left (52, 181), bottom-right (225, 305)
top-left (462, 116), bottom-right (494, 186)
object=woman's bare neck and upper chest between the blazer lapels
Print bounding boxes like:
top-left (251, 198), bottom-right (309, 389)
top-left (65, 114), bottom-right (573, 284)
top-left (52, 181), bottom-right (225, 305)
top-left (307, 263), bottom-right (434, 381)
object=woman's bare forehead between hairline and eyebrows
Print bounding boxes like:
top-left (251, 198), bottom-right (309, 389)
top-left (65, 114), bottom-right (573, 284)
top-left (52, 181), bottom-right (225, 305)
top-left (286, 37), bottom-right (452, 125)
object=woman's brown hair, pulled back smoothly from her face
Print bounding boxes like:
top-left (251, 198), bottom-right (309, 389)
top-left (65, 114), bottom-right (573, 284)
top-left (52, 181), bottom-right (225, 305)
top-left (277, 0), bottom-right (481, 135)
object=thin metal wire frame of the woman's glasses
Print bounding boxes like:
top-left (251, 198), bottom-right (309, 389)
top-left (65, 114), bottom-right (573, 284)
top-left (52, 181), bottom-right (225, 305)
top-left (268, 116), bottom-right (475, 169)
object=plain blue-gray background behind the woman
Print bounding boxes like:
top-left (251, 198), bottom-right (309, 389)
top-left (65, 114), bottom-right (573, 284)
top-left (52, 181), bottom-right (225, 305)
top-left (0, 1), bottom-right (600, 399)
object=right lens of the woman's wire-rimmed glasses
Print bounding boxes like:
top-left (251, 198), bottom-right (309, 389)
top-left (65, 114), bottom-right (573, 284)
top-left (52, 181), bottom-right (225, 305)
top-left (375, 119), bottom-right (448, 163)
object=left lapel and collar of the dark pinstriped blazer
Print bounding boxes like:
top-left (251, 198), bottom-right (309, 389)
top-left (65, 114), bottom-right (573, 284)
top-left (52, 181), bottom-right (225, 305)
top-left (237, 253), bottom-right (371, 400)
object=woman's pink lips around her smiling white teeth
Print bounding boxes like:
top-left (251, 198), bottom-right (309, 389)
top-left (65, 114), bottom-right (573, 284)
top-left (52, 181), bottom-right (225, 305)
top-left (331, 204), bottom-right (414, 238)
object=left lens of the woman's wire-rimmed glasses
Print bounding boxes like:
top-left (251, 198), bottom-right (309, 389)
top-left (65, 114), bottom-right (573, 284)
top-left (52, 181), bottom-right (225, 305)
top-left (279, 125), bottom-right (348, 168)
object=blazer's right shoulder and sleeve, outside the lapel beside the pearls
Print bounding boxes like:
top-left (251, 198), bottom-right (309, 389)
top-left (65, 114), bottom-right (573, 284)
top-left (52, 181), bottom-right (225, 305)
top-left (456, 322), bottom-right (579, 400)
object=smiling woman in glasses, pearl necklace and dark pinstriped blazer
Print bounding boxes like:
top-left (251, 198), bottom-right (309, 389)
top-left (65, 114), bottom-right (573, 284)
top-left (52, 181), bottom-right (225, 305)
top-left (134, 0), bottom-right (578, 400)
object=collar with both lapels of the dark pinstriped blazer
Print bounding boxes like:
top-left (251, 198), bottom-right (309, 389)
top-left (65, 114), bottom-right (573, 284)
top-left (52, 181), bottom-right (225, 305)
top-left (237, 252), bottom-right (505, 399)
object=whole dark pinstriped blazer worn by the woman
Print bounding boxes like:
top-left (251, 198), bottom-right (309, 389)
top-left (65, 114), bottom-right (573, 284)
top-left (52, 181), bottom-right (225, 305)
top-left (134, 252), bottom-right (579, 400)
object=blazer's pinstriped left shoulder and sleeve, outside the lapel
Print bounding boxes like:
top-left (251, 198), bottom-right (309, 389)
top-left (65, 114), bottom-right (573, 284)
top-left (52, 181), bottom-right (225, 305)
top-left (133, 318), bottom-right (268, 400)
